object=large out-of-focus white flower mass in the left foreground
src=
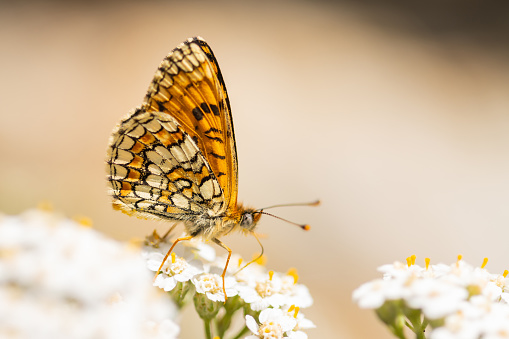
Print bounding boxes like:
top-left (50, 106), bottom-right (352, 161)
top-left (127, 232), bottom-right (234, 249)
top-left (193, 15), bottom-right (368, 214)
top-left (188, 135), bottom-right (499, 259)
top-left (0, 210), bottom-right (179, 339)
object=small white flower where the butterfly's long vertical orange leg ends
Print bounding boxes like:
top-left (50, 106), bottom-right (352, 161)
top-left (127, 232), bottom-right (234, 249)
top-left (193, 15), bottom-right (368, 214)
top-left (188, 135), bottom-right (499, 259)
top-left (191, 273), bottom-right (237, 302)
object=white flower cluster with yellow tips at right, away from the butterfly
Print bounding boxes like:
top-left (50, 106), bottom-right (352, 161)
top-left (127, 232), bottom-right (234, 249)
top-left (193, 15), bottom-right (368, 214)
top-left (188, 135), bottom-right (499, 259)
top-left (353, 256), bottom-right (509, 339)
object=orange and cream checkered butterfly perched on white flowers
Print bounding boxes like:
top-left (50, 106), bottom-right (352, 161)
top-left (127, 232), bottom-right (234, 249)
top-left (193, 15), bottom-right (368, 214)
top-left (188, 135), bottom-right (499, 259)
top-left (107, 37), bottom-right (309, 300)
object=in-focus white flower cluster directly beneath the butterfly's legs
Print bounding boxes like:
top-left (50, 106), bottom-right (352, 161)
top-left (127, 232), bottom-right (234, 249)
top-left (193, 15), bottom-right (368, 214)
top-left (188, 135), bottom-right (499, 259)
top-left (143, 235), bottom-right (315, 339)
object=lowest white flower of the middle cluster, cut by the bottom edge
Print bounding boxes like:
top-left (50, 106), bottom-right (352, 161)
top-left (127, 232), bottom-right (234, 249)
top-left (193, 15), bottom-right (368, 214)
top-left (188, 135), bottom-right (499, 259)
top-left (246, 308), bottom-right (299, 339)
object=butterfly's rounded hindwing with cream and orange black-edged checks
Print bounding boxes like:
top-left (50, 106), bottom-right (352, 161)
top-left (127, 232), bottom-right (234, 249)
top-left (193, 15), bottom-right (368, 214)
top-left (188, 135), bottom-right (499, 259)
top-left (107, 109), bottom-right (223, 220)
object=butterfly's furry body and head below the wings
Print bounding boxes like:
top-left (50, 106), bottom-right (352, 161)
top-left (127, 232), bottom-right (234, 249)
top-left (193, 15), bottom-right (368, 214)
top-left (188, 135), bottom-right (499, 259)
top-left (184, 204), bottom-right (261, 240)
